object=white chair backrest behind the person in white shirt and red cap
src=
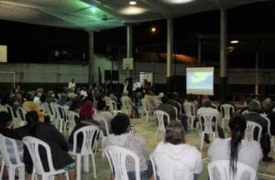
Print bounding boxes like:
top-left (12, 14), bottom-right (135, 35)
top-left (199, 114), bottom-right (219, 134)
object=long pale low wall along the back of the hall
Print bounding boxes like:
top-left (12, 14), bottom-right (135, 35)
top-left (0, 56), bottom-right (275, 84)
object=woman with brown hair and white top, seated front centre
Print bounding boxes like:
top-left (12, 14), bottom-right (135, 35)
top-left (152, 121), bottom-right (203, 180)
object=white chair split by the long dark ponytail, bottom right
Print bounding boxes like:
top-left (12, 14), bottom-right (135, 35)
top-left (207, 160), bottom-right (257, 180)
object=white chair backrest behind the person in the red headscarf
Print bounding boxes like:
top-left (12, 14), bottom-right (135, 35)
top-left (72, 125), bottom-right (100, 155)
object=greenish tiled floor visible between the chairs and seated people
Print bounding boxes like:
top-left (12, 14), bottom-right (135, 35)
top-left (78, 116), bottom-right (275, 180)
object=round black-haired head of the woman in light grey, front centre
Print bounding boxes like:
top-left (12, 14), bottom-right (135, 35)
top-left (111, 113), bottom-right (130, 135)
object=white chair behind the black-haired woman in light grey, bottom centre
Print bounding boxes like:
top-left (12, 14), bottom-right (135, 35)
top-left (104, 145), bottom-right (140, 180)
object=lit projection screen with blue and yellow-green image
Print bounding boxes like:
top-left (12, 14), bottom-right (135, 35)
top-left (186, 67), bottom-right (214, 95)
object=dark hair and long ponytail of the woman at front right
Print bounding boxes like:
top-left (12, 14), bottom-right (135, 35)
top-left (228, 114), bottom-right (246, 176)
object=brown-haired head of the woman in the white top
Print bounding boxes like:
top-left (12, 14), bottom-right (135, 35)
top-left (165, 121), bottom-right (185, 145)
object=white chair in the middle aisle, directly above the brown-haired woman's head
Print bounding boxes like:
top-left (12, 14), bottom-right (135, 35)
top-left (154, 110), bottom-right (170, 145)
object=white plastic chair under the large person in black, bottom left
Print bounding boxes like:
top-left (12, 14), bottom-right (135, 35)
top-left (23, 136), bottom-right (69, 180)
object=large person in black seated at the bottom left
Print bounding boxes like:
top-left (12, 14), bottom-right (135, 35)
top-left (0, 111), bottom-right (75, 180)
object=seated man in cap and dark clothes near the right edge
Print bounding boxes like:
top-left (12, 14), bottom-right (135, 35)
top-left (244, 99), bottom-right (273, 162)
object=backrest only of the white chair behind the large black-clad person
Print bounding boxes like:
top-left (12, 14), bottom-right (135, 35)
top-left (23, 136), bottom-right (56, 175)
